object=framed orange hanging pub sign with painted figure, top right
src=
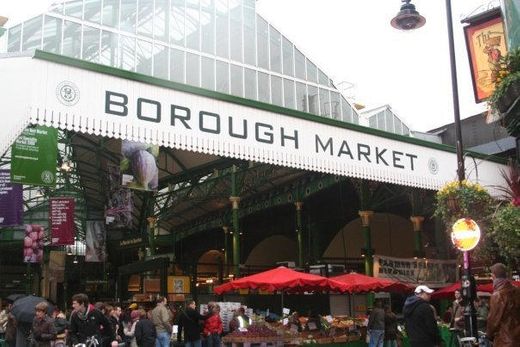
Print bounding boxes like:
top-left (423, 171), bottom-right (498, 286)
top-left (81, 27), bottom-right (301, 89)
top-left (464, 9), bottom-right (507, 103)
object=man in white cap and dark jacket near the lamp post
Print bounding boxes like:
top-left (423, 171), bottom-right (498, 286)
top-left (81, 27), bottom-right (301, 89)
top-left (403, 285), bottom-right (441, 347)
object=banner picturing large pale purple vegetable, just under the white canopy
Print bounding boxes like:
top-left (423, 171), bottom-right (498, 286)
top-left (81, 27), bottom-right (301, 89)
top-left (121, 141), bottom-right (159, 191)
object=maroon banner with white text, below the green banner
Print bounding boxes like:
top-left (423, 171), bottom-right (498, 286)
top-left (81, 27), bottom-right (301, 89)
top-left (49, 198), bottom-right (75, 246)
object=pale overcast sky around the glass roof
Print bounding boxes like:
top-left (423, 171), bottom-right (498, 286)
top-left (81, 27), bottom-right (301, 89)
top-left (0, 0), bottom-right (499, 131)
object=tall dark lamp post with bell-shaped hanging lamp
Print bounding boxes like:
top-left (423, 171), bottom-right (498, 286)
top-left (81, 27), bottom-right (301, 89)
top-left (390, 0), bottom-right (478, 339)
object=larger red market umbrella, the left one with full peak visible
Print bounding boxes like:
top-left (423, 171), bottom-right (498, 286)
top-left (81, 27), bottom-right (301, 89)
top-left (213, 266), bottom-right (345, 294)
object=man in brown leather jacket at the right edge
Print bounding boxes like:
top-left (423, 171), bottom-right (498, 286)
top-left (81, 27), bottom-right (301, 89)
top-left (486, 263), bottom-right (520, 347)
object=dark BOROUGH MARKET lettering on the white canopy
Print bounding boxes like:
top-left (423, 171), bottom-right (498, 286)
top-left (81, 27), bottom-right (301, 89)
top-left (105, 90), bottom-right (417, 171)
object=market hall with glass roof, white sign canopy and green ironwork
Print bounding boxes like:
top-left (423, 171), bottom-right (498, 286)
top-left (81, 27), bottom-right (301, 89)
top-left (0, 0), bottom-right (505, 316)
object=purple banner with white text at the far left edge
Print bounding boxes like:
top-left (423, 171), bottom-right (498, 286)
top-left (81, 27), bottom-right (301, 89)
top-left (0, 170), bottom-right (23, 227)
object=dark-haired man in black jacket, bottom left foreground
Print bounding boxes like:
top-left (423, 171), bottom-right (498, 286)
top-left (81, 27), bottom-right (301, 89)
top-left (69, 294), bottom-right (112, 345)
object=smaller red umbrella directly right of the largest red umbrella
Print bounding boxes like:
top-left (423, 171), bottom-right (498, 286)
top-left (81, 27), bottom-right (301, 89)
top-left (331, 272), bottom-right (413, 293)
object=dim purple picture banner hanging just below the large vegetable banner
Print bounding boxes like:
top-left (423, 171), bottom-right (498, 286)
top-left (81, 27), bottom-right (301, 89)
top-left (105, 165), bottom-right (134, 228)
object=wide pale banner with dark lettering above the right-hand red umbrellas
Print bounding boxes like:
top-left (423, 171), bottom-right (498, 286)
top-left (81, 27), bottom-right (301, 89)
top-left (374, 255), bottom-right (458, 287)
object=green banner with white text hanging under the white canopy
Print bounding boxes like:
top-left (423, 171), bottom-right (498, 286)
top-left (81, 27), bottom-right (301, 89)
top-left (11, 126), bottom-right (58, 187)
